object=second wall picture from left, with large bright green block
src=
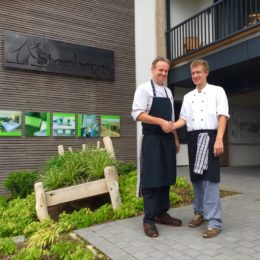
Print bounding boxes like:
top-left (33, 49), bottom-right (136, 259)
top-left (25, 112), bottom-right (51, 136)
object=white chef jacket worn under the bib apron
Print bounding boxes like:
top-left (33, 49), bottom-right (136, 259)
top-left (131, 81), bottom-right (175, 122)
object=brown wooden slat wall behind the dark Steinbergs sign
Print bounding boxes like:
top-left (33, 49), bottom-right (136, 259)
top-left (0, 0), bottom-right (136, 194)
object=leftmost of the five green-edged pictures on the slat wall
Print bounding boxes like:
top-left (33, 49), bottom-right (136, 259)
top-left (0, 110), bottom-right (22, 136)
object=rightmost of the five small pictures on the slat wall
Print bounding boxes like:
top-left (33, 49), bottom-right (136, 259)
top-left (100, 115), bottom-right (120, 137)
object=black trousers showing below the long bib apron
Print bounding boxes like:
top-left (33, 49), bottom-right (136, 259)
top-left (142, 186), bottom-right (170, 223)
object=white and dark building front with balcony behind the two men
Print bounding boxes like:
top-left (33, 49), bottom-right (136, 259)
top-left (135, 0), bottom-right (260, 166)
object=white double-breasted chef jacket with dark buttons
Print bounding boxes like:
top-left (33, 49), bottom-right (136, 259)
top-left (180, 84), bottom-right (230, 131)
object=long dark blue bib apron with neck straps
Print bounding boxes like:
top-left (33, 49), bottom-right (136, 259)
top-left (140, 81), bottom-right (176, 188)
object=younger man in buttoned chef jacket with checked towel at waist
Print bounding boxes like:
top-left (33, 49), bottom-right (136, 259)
top-left (173, 60), bottom-right (229, 238)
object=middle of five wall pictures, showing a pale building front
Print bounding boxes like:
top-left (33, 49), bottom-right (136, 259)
top-left (53, 113), bottom-right (75, 136)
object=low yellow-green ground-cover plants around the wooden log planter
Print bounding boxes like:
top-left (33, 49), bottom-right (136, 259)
top-left (0, 165), bottom-right (195, 260)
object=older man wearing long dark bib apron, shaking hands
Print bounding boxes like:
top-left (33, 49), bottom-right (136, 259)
top-left (132, 57), bottom-right (182, 237)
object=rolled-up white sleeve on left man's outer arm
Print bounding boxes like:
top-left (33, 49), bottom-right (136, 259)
top-left (131, 85), bottom-right (149, 121)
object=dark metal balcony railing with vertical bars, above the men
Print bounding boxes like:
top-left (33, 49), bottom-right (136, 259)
top-left (166, 0), bottom-right (260, 60)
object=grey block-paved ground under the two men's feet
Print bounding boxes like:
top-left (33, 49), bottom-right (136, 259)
top-left (75, 166), bottom-right (260, 260)
